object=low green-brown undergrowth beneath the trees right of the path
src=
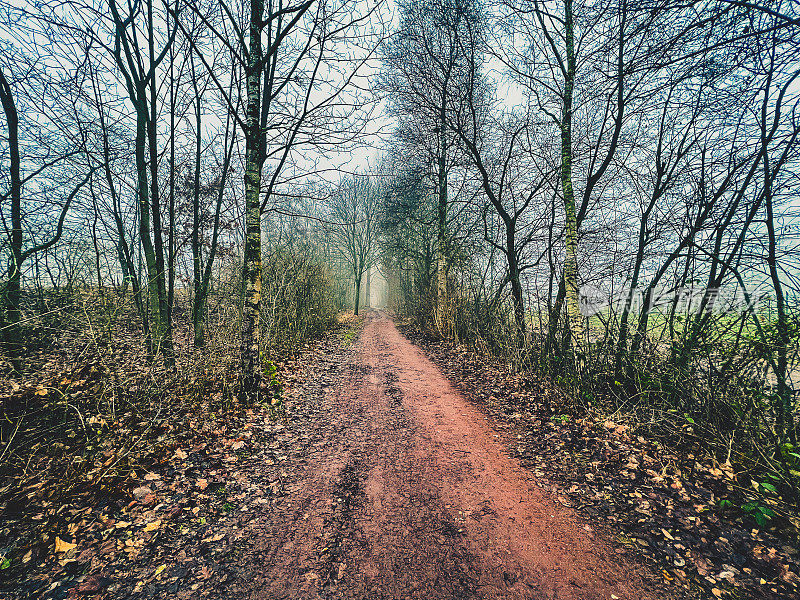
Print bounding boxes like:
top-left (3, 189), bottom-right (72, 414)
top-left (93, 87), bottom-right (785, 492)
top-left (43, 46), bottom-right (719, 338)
top-left (404, 297), bottom-right (800, 528)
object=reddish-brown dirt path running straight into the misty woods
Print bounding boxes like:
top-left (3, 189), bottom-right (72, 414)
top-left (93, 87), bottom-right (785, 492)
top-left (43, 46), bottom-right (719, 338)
top-left (222, 313), bottom-right (656, 600)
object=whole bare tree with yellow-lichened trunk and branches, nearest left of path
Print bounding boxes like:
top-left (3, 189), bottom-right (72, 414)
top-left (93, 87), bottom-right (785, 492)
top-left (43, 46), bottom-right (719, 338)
top-left (179, 0), bottom-right (380, 402)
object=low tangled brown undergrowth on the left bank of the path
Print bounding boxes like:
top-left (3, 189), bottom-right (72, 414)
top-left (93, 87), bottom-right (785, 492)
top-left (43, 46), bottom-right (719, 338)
top-left (0, 292), bottom-right (335, 580)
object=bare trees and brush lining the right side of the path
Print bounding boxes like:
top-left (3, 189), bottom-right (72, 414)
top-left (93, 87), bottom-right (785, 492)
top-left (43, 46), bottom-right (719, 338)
top-left (381, 0), bottom-right (800, 526)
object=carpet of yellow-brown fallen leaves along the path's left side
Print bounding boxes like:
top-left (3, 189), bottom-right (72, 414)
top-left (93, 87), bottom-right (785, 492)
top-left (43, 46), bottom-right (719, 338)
top-left (0, 323), bottom-right (360, 598)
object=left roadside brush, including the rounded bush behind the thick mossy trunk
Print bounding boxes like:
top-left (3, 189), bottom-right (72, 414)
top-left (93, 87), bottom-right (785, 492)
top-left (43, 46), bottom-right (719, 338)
top-left (0, 239), bottom-right (338, 593)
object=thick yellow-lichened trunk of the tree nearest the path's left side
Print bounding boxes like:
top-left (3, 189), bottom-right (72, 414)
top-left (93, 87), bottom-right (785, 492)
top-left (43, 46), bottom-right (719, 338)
top-left (239, 0), bottom-right (264, 404)
